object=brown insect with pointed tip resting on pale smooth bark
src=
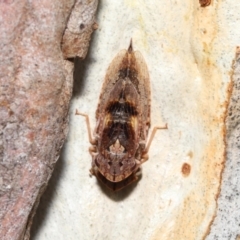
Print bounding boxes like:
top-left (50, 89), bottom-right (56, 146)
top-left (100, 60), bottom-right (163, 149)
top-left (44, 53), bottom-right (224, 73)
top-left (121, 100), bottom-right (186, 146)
top-left (76, 41), bottom-right (167, 191)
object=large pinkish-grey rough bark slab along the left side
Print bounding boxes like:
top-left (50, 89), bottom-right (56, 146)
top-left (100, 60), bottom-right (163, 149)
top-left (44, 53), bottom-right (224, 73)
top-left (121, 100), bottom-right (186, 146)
top-left (0, 0), bottom-right (96, 240)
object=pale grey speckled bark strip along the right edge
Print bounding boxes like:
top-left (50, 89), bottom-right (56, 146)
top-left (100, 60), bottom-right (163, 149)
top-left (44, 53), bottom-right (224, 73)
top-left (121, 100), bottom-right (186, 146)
top-left (207, 47), bottom-right (240, 240)
